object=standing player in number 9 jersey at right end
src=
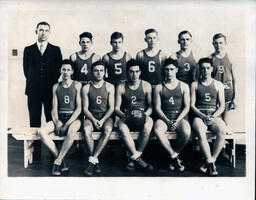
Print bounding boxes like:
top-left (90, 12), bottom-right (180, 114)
top-left (210, 33), bottom-right (236, 160)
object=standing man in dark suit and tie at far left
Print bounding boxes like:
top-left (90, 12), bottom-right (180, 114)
top-left (23, 22), bottom-right (62, 159)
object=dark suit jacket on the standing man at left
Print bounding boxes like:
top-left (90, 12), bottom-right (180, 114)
top-left (23, 42), bottom-right (62, 95)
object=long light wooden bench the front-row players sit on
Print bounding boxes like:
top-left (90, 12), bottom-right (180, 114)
top-left (8, 128), bottom-right (245, 168)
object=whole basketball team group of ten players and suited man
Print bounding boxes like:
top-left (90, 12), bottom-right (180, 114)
top-left (23, 22), bottom-right (236, 176)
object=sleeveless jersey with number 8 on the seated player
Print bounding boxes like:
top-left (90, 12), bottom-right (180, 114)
top-left (56, 81), bottom-right (76, 111)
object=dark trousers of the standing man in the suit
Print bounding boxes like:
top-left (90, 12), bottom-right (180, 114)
top-left (28, 93), bottom-right (52, 160)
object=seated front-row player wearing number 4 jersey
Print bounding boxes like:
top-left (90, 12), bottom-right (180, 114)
top-left (154, 58), bottom-right (191, 172)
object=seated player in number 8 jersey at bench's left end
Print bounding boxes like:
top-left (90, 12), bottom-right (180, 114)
top-left (38, 60), bottom-right (82, 176)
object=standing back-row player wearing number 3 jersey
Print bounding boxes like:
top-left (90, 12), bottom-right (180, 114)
top-left (170, 31), bottom-right (198, 86)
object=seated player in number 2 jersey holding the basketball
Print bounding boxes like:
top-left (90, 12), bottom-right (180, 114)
top-left (115, 59), bottom-right (153, 172)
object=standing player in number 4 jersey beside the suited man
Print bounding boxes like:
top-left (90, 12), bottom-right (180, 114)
top-left (70, 32), bottom-right (100, 85)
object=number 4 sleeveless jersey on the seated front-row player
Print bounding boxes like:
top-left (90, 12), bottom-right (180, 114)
top-left (161, 81), bottom-right (183, 113)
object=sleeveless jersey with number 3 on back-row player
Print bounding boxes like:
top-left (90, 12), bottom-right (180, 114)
top-left (176, 51), bottom-right (197, 85)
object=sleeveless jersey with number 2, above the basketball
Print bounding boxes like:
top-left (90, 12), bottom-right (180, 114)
top-left (122, 80), bottom-right (146, 110)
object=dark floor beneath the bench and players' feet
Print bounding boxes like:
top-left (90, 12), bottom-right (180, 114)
top-left (8, 135), bottom-right (246, 177)
